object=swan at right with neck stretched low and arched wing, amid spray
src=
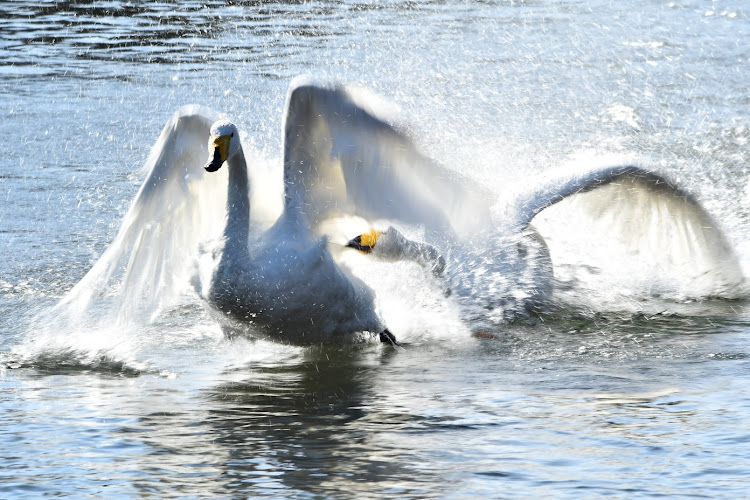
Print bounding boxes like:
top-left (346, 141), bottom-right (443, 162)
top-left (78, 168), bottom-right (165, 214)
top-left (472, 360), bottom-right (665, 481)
top-left (348, 164), bottom-right (747, 323)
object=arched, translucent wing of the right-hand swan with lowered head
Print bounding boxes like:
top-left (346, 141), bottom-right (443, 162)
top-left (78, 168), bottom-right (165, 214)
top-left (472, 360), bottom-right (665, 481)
top-left (515, 165), bottom-right (745, 297)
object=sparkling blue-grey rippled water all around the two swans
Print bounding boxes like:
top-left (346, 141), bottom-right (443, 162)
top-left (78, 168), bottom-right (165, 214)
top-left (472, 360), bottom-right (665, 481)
top-left (0, 0), bottom-right (750, 498)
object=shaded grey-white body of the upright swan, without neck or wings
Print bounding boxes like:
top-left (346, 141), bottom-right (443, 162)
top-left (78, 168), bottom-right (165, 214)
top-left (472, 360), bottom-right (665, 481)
top-left (206, 236), bottom-right (383, 344)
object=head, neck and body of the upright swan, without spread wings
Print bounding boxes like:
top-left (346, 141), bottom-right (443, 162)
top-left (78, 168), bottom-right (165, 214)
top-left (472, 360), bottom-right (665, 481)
top-left (194, 116), bottom-right (395, 344)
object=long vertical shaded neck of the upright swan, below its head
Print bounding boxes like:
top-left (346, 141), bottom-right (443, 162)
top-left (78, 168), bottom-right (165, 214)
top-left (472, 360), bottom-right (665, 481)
top-left (224, 147), bottom-right (250, 252)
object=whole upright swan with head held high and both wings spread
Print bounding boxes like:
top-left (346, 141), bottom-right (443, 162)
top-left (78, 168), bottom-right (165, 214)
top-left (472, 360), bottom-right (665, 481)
top-left (55, 80), bottom-right (489, 344)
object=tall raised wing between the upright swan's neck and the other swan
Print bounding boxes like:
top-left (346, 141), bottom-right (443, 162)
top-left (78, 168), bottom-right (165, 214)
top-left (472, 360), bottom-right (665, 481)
top-left (284, 80), bottom-right (490, 240)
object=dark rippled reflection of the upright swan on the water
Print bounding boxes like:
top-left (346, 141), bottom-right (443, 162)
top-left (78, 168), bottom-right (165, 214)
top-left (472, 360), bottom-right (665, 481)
top-left (202, 347), bottom-right (446, 498)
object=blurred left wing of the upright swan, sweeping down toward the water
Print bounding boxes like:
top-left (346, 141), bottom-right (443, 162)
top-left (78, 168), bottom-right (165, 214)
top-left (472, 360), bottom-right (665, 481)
top-left (58, 106), bottom-right (227, 321)
